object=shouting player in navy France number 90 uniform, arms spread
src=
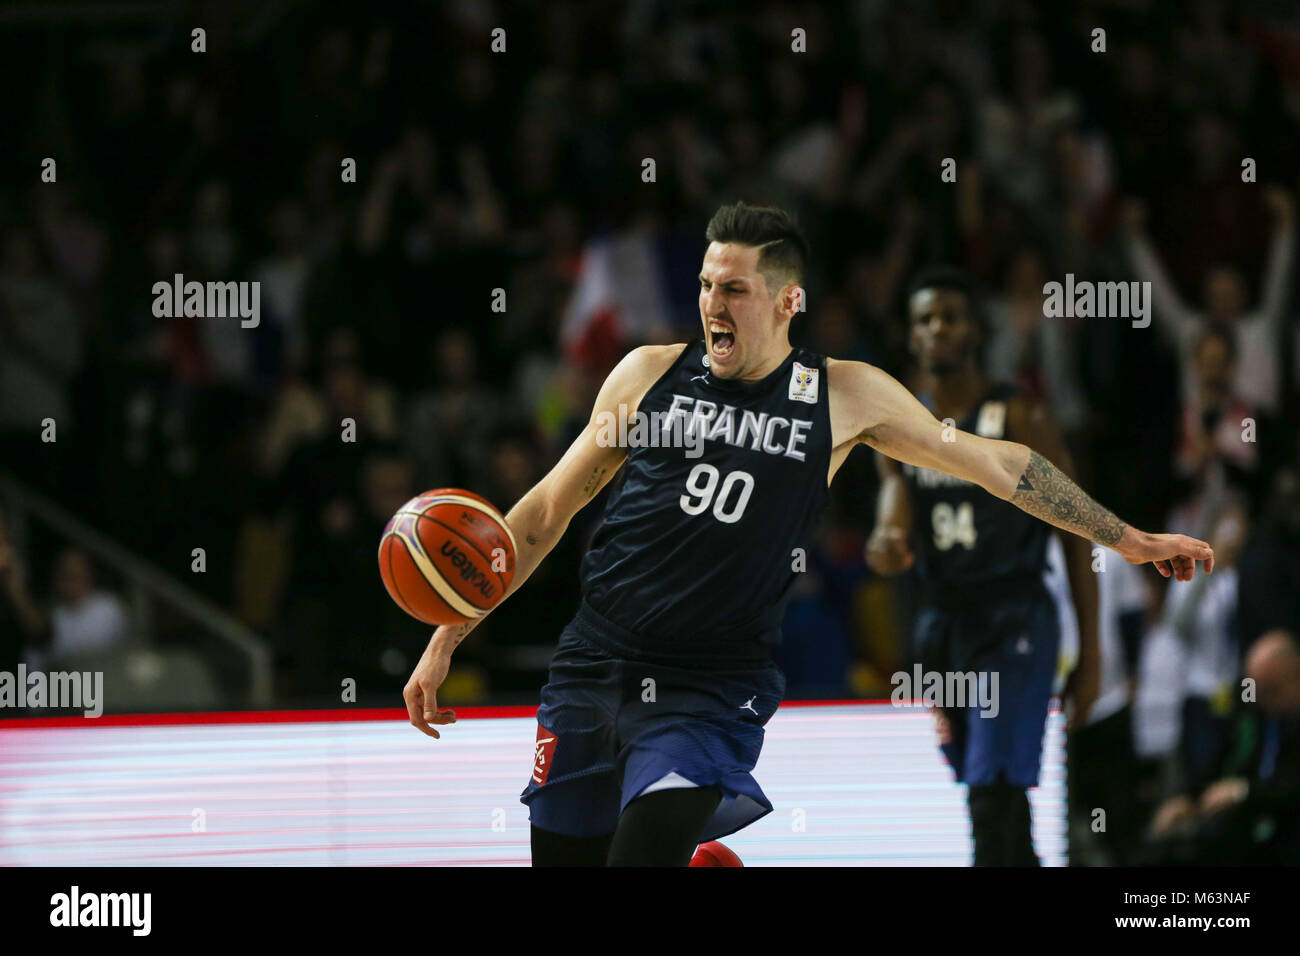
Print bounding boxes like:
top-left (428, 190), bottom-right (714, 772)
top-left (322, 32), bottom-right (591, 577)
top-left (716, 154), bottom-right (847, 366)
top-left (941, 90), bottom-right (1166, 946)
top-left (403, 204), bottom-right (1213, 866)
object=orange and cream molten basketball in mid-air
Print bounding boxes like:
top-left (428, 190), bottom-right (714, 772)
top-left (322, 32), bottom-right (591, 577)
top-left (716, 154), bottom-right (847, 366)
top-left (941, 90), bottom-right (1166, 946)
top-left (380, 488), bottom-right (515, 624)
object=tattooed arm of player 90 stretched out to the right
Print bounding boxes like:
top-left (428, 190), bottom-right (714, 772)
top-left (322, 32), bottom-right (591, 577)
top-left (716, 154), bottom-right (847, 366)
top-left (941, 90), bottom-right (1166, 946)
top-left (827, 362), bottom-right (1214, 580)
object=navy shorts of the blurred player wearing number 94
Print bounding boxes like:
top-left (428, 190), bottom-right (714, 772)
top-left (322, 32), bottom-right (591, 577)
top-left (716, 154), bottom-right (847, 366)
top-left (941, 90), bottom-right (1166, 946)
top-left (915, 588), bottom-right (1061, 787)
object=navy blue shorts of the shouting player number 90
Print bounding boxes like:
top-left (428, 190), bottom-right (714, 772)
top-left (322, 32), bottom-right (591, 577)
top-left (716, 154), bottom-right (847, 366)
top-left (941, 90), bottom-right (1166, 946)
top-left (520, 624), bottom-right (785, 843)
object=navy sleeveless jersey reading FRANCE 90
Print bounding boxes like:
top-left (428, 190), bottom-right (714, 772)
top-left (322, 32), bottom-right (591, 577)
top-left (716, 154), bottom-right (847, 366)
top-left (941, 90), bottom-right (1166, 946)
top-left (579, 339), bottom-right (831, 661)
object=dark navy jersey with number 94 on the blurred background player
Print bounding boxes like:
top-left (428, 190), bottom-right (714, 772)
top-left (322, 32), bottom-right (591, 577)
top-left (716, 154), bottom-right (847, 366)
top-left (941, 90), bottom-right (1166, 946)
top-left (902, 384), bottom-right (1052, 592)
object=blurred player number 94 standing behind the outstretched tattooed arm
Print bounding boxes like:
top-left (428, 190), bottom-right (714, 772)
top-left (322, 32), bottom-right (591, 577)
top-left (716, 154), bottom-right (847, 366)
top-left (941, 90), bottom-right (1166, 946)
top-left (867, 268), bottom-right (1101, 866)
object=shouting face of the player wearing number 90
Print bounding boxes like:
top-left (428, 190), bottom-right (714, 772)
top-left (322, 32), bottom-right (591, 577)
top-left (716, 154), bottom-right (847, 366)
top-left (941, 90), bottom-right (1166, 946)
top-left (699, 242), bottom-right (793, 381)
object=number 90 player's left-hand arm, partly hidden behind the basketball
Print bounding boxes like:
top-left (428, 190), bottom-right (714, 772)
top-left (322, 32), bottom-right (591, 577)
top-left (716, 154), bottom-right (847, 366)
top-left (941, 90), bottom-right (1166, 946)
top-left (402, 345), bottom-right (681, 737)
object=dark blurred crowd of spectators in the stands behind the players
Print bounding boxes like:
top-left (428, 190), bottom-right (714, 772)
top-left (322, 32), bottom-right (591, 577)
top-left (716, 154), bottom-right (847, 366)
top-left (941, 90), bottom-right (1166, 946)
top-left (0, 0), bottom-right (1300, 853)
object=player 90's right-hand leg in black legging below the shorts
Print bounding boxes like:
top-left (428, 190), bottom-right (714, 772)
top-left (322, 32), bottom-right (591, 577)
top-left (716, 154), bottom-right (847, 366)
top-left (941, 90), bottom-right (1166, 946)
top-left (608, 787), bottom-right (723, 866)
